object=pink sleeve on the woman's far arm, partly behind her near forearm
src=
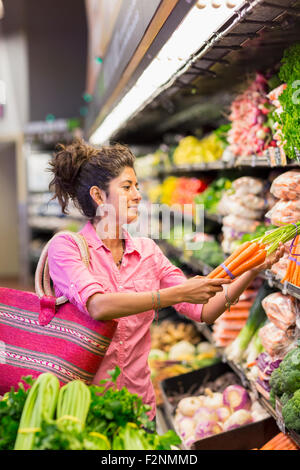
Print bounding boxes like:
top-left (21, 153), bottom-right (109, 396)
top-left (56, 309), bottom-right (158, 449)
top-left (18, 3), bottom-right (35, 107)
top-left (153, 242), bottom-right (203, 322)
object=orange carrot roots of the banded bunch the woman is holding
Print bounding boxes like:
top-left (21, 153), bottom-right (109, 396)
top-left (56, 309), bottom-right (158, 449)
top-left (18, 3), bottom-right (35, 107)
top-left (207, 241), bottom-right (267, 279)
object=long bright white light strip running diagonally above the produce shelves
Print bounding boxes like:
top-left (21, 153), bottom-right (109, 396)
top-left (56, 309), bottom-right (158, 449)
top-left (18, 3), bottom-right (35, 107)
top-left (90, 0), bottom-right (245, 145)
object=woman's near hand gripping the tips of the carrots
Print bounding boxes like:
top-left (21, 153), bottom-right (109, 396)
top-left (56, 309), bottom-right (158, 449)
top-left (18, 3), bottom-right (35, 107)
top-left (178, 276), bottom-right (232, 304)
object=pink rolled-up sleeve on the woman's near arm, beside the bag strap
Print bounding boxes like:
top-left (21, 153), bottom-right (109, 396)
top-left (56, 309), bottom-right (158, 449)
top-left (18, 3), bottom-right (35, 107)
top-left (48, 234), bottom-right (105, 313)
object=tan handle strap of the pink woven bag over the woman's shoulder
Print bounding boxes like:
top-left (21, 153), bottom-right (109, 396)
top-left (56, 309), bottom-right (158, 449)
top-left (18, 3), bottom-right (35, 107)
top-left (35, 231), bottom-right (90, 305)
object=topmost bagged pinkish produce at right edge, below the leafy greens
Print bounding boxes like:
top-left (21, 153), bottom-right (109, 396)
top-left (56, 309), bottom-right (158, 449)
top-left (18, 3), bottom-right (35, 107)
top-left (270, 170), bottom-right (300, 200)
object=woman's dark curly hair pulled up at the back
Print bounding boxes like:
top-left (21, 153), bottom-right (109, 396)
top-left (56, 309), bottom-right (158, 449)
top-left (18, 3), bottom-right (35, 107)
top-left (49, 139), bottom-right (135, 219)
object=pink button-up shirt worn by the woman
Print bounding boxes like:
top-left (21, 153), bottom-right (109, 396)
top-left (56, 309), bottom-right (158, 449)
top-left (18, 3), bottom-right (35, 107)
top-left (48, 222), bottom-right (202, 418)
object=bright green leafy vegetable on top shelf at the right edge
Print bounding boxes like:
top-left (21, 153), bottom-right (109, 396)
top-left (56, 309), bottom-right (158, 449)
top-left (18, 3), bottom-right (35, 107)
top-left (274, 43), bottom-right (300, 158)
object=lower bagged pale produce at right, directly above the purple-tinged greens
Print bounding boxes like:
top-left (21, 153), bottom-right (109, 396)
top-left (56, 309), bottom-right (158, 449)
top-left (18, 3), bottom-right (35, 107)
top-left (258, 322), bottom-right (293, 357)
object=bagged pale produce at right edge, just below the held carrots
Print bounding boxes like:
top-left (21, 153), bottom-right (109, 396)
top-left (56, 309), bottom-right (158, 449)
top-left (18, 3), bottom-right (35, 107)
top-left (262, 292), bottom-right (296, 331)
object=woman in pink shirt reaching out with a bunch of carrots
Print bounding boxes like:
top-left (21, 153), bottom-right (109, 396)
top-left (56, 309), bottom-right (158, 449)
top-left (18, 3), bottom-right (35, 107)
top-left (48, 141), bottom-right (283, 418)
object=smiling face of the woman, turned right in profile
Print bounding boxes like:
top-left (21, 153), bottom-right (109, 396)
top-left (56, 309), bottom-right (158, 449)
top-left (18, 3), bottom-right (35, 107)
top-left (105, 167), bottom-right (142, 225)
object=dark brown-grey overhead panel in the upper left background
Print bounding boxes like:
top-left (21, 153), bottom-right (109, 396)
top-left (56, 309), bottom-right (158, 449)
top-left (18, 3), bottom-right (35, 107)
top-left (2, 0), bottom-right (87, 121)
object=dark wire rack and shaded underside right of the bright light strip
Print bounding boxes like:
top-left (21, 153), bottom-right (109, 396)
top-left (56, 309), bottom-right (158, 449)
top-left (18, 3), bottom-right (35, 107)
top-left (113, 0), bottom-right (300, 144)
